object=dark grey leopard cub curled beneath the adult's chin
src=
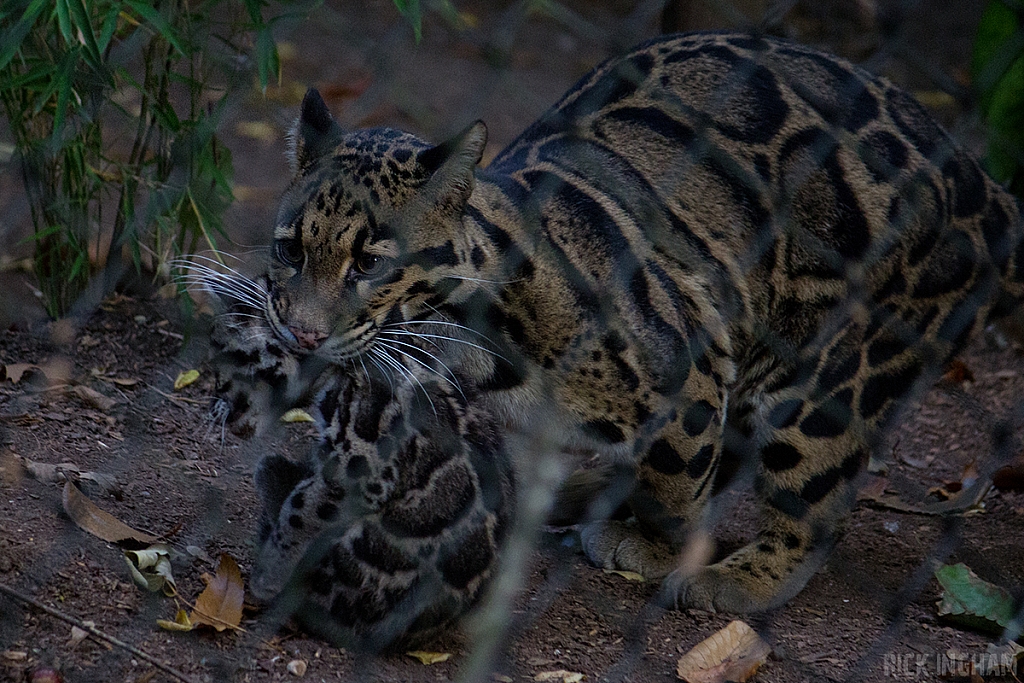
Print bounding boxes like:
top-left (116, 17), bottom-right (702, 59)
top-left (196, 290), bottom-right (514, 650)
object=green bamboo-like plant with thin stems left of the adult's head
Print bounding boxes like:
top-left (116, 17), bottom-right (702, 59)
top-left (0, 0), bottom-right (309, 316)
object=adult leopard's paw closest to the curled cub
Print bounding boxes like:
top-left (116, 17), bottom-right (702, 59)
top-left (580, 521), bottom-right (676, 579)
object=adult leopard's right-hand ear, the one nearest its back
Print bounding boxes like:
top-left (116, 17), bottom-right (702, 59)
top-left (416, 121), bottom-right (487, 210)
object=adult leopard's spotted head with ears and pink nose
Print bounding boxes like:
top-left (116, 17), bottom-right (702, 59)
top-left (266, 89), bottom-right (486, 362)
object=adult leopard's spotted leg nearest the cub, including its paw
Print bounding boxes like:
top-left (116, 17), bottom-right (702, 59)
top-left (581, 364), bottom-right (725, 579)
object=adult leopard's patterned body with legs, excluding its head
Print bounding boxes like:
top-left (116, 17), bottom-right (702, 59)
top-left (470, 34), bottom-right (1024, 611)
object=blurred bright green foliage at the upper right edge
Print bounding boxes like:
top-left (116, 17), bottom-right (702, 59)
top-left (971, 0), bottom-right (1024, 198)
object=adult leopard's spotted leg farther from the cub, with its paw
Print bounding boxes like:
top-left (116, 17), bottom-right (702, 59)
top-left (664, 322), bottom-right (929, 612)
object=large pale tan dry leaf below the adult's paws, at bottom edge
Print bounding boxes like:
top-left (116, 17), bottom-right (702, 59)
top-left (676, 620), bottom-right (771, 683)
